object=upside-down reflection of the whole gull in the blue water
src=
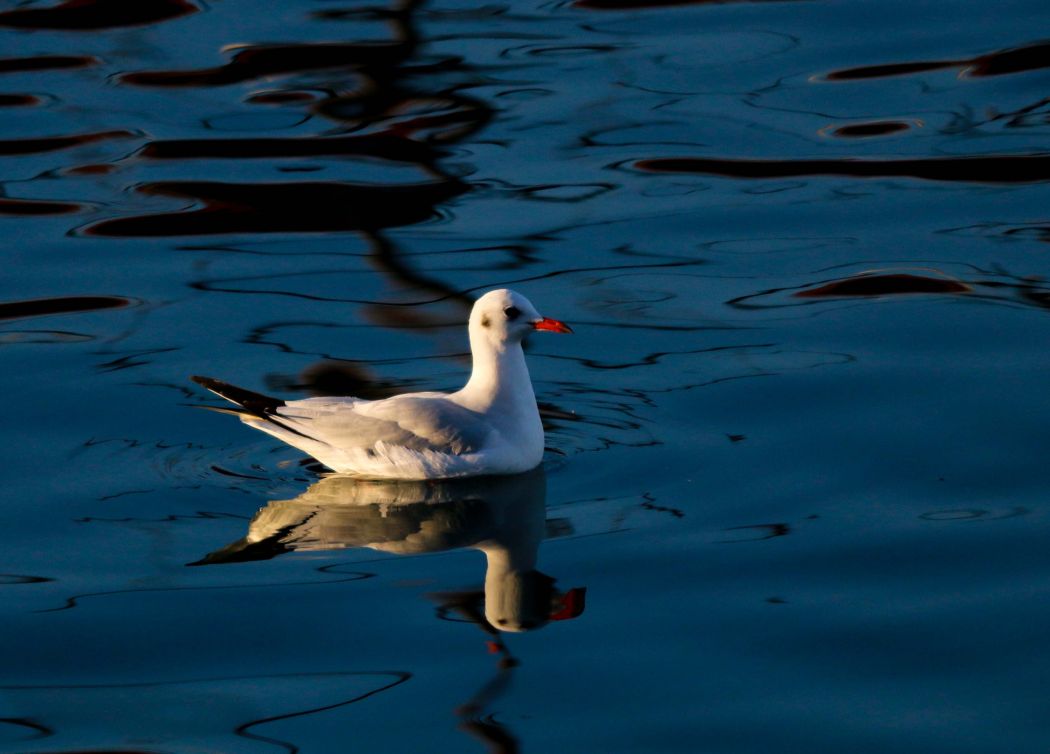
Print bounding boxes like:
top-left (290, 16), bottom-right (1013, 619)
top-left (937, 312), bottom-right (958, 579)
top-left (193, 468), bottom-right (583, 631)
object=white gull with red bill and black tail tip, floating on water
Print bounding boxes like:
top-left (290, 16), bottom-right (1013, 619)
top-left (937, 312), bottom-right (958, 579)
top-left (190, 289), bottom-right (572, 480)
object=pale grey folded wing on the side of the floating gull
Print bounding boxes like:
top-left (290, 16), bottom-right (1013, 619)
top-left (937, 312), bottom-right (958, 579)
top-left (273, 393), bottom-right (491, 456)
